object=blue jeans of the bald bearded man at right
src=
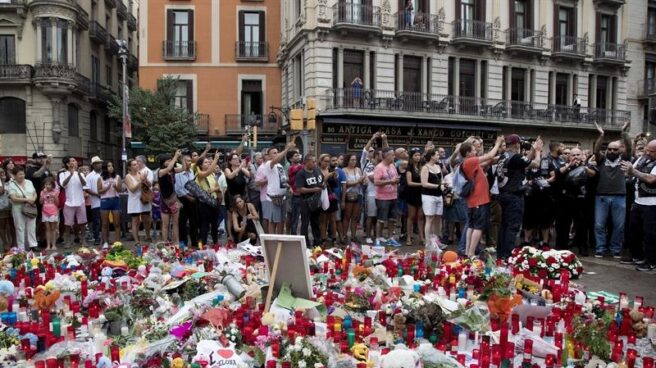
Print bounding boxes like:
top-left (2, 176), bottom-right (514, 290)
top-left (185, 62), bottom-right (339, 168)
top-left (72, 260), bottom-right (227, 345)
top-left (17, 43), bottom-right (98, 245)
top-left (595, 195), bottom-right (626, 255)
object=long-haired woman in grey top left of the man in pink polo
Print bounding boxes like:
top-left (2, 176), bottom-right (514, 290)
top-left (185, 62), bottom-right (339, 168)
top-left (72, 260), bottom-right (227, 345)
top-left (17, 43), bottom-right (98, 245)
top-left (342, 154), bottom-right (367, 242)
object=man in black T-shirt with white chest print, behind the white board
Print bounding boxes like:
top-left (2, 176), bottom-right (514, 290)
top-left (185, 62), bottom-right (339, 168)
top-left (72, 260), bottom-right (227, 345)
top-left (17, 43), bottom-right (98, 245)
top-left (296, 153), bottom-right (326, 247)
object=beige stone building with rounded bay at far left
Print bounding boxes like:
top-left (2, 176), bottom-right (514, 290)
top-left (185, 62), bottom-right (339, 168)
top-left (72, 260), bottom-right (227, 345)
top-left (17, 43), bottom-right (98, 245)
top-left (0, 0), bottom-right (138, 165)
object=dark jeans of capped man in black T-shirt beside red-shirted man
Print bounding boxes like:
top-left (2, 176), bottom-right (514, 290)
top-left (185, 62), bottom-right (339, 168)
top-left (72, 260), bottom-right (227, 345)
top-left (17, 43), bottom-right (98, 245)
top-left (497, 193), bottom-right (524, 259)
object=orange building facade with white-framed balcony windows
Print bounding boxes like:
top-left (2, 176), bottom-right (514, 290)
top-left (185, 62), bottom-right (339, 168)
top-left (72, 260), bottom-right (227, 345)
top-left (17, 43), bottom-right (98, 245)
top-left (139, 0), bottom-right (281, 148)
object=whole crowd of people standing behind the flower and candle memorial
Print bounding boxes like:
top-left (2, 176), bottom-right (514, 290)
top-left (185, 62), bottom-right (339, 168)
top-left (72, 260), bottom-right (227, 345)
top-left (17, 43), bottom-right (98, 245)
top-left (0, 123), bottom-right (656, 271)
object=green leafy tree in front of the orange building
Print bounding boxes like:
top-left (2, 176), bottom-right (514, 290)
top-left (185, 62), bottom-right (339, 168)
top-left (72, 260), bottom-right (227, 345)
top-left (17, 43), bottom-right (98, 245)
top-left (109, 77), bottom-right (197, 155)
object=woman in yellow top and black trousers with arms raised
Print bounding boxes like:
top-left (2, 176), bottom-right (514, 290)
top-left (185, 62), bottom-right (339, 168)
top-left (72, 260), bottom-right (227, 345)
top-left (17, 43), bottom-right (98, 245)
top-left (195, 153), bottom-right (221, 244)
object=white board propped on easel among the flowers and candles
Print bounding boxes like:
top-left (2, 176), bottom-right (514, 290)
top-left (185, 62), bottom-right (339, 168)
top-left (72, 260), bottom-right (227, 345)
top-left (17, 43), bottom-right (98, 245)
top-left (260, 234), bottom-right (314, 308)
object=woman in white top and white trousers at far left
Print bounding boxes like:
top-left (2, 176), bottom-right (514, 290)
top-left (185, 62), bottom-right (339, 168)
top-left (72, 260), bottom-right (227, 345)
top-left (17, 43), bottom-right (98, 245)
top-left (9, 166), bottom-right (37, 250)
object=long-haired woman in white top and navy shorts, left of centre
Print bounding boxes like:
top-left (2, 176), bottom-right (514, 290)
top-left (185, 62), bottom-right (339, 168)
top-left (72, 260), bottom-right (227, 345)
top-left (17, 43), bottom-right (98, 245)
top-left (96, 161), bottom-right (122, 246)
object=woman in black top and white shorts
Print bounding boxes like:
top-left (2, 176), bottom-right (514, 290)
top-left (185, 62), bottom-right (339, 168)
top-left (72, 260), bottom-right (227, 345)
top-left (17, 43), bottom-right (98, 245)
top-left (421, 150), bottom-right (444, 247)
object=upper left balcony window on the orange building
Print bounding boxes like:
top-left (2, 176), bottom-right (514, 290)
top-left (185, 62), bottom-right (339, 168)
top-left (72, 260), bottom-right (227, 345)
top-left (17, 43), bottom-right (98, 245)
top-left (166, 9), bottom-right (195, 57)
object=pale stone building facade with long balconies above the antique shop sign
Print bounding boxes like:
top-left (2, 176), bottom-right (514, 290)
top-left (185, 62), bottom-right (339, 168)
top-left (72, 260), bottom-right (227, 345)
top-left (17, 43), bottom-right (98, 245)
top-left (279, 0), bottom-right (640, 152)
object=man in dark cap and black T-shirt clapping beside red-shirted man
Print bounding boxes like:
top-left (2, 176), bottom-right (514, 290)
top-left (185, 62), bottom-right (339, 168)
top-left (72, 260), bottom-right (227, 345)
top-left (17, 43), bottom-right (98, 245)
top-left (496, 134), bottom-right (543, 258)
